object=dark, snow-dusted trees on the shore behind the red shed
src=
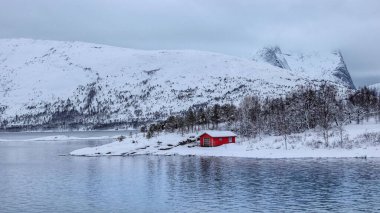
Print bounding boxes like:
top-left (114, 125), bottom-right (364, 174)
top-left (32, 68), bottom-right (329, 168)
top-left (142, 82), bottom-right (380, 146)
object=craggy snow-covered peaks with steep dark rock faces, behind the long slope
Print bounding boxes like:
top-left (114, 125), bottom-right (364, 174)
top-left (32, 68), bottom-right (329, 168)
top-left (254, 46), bottom-right (355, 89)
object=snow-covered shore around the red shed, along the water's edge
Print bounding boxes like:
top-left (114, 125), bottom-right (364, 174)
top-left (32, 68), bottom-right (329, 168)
top-left (70, 121), bottom-right (380, 158)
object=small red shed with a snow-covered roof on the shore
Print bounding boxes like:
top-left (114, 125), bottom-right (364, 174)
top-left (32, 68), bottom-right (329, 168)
top-left (198, 130), bottom-right (236, 147)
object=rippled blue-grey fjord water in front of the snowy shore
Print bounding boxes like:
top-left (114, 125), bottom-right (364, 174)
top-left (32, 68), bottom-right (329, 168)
top-left (0, 137), bottom-right (380, 212)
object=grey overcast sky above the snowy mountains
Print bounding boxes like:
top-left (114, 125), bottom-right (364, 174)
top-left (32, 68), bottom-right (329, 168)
top-left (0, 0), bottom-right (380, 86)
